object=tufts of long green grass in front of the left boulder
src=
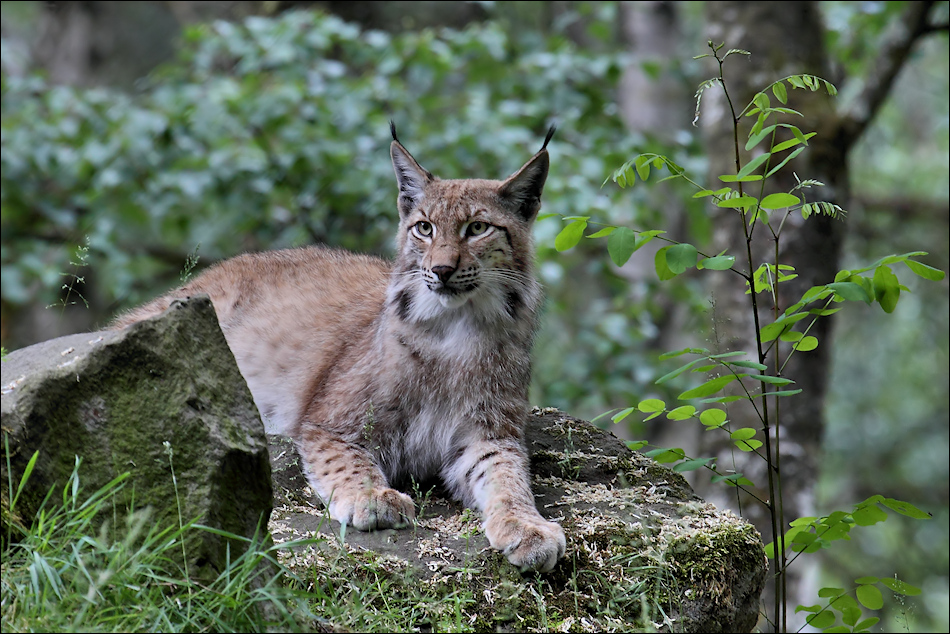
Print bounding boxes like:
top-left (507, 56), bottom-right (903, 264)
top-left (0, 450), bottom-right (313, 632)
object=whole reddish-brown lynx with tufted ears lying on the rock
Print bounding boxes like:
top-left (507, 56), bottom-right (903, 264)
top-left (114, 126), bottom-right (565, 571)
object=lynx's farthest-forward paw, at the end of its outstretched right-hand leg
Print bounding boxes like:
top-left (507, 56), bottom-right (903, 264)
top-left (485, 515), bottom-right (567, 572)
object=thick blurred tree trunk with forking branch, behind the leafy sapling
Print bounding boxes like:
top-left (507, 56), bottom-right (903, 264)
top-left (697, 2), bottom-right (932, 628)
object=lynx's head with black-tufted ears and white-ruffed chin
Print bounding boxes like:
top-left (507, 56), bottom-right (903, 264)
top-left (390, 126), bottom-right (554, 321)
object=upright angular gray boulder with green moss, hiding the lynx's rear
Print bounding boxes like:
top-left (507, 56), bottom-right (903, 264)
top-left (0, 296), bottom-right (272, 578)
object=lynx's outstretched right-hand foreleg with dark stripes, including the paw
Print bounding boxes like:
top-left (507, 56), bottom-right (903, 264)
top-left (444, 440), bottom-right (566, 572)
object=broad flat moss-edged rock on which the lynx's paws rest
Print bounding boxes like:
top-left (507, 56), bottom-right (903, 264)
top-left (268, 408), bottom-right (768, 632)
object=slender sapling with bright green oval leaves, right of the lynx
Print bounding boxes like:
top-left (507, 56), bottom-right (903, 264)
top-left (555, 42), bottom-right (945, 631)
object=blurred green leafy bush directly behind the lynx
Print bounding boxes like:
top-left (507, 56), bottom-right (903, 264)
top-left (0, 12), bottom-right (684, 407)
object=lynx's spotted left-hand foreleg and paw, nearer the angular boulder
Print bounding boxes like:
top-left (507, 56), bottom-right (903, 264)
top-left (299, 428), bottom-right (416, 531)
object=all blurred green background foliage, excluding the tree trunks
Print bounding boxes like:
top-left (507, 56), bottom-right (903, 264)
top-left (0, 3), bottom-right (950, 631)
